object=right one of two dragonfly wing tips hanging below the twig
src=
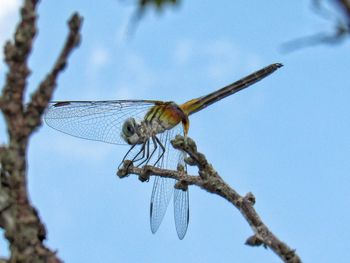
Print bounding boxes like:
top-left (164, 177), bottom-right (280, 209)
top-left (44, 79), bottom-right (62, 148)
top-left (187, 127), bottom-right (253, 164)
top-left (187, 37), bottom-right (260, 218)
top-left (174, 189), bottom-right (190, 239)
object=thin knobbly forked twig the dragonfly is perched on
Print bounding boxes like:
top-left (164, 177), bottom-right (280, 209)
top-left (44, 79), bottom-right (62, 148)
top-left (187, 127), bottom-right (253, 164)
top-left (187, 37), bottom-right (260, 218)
top-left (117, 135), bottom-right (301, 263)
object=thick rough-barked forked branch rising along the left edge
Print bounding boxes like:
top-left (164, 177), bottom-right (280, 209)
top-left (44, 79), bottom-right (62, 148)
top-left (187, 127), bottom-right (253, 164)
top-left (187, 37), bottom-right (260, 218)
top-left (0, 0), bottom-right (82, 263)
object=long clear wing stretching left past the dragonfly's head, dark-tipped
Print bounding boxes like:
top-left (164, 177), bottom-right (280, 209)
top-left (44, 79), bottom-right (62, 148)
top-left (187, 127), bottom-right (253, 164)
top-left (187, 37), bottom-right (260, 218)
top-left (44, 100), bottom-right (161, 144)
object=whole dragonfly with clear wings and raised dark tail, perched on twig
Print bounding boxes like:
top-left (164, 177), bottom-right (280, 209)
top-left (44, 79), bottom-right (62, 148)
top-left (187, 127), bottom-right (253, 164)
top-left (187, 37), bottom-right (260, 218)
top-left (44, 63), bottom-right (282, 239)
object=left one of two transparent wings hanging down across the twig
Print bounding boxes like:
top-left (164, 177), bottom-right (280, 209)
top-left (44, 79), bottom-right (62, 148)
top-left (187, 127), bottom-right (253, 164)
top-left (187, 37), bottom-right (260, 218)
top-left (150, 124), bottom-right (183, 236)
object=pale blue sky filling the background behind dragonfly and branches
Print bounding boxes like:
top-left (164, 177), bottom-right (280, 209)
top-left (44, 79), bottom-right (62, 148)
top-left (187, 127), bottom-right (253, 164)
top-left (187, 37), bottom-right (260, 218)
top-left (0, 0), bottom-right (350, 263)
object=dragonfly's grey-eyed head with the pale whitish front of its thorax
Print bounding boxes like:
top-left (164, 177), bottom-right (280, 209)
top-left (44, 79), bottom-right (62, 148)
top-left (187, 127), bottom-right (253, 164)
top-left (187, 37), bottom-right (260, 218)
top-left (121, 118), bottom-right (166, 145)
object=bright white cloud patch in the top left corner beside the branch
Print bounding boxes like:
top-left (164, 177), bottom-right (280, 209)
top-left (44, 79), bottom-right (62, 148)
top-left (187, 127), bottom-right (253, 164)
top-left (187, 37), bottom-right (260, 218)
top-left (0, 0), bottom-right (20, 72)
